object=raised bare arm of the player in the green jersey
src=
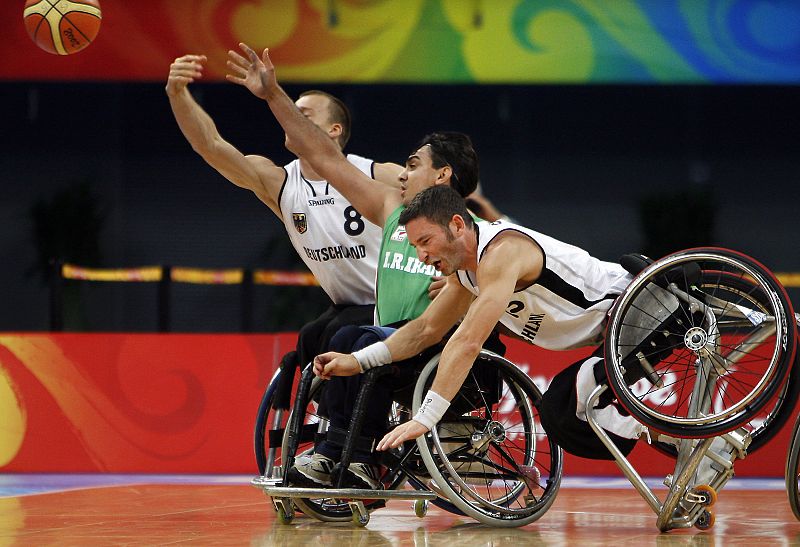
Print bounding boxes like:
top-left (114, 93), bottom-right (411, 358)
top-left (226, 43), bottom-right (401, 226)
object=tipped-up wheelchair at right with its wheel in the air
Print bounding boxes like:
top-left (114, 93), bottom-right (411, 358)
top-left (586, 248), bottom-right (797, 531)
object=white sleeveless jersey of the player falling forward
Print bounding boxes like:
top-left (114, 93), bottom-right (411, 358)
top-left (458, 220), bottom-right (632, 350)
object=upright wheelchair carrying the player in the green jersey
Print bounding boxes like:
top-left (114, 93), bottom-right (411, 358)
top-left (252, 350), bottom-right (563, 527)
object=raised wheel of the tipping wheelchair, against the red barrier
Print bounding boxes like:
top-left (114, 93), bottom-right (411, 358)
top-left (605, 248), bottom-right (796, 438)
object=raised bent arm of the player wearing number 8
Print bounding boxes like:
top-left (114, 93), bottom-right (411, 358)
top-left (166, 55), bottom-right (286, 215)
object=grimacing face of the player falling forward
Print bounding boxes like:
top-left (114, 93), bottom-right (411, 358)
top-left (406, 217), bottom-right (465, 275)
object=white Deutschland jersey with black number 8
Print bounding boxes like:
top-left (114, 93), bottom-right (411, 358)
top-left (278, 154), bottom-right (382, 305)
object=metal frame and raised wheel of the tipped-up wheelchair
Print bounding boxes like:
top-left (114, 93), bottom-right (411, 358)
top-left (586, 249), bottom-right (800, 531)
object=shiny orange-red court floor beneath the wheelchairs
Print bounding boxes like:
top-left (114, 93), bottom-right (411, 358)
top-left (0, 478), bottom-right (800, 547)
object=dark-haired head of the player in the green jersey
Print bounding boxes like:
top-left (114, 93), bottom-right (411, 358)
top-left (400, 131), bottom-right (479, 204)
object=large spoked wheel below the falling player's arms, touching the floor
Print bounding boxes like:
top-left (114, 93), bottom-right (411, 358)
top-left (413, 350), bottom-right (563, 527)
